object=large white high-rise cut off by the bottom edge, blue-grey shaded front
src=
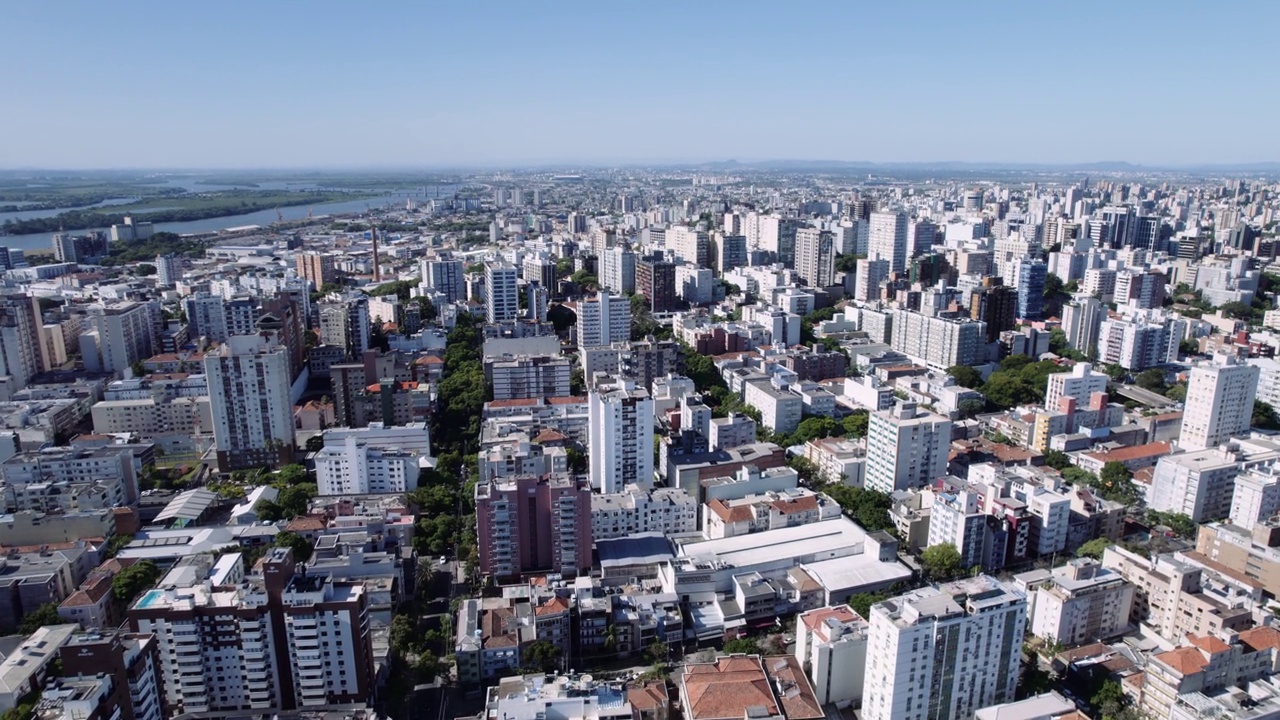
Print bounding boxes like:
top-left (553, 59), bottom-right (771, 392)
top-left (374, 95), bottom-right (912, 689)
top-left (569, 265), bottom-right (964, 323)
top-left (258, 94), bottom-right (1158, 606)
top-left (863, 575), bottom-right (1027, 720)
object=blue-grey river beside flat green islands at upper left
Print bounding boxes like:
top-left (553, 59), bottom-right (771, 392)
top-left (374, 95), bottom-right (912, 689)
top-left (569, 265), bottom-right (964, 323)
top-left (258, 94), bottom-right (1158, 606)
top-left (0, 183), bottom-right (462, 251)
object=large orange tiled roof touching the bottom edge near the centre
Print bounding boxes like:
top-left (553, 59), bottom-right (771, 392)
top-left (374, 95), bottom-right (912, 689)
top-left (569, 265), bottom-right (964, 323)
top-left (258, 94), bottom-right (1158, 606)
top-left (681, 655), bottom-right (778, 720)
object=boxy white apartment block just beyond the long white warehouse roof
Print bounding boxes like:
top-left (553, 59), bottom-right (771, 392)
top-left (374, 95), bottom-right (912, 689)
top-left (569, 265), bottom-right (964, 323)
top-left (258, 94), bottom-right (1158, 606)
top-left (867, 401), bottom-right (951, 492)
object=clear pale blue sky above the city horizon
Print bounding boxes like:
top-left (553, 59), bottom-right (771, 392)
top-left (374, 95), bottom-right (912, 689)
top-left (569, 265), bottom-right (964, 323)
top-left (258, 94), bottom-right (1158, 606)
top-left (0, 0), bottom-right (1280, 169)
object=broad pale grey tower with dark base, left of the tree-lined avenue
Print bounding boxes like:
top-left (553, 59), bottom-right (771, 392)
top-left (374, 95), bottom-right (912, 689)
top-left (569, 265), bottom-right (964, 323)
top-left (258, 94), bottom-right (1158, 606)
top-left (205, 334), bottom-right (293, 471)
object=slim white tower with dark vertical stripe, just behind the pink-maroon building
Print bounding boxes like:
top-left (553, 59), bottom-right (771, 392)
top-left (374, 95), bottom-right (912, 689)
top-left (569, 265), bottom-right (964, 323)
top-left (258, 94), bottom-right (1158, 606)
top-left (588, 371), bottom-right (654, 493)
